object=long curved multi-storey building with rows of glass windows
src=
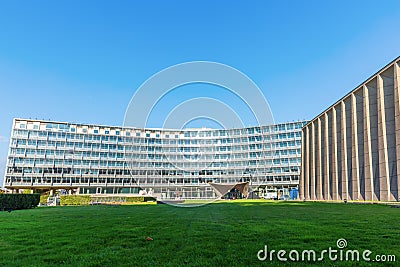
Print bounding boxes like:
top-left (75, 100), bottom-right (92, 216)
top-left (4, 119), bottom-right (305, 199)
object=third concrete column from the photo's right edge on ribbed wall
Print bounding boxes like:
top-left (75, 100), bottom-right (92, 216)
top-left (363, 85), bottom-right (374, 200)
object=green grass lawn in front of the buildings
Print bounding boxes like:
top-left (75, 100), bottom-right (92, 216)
top-left (0, 200), bottom-right (400, 266)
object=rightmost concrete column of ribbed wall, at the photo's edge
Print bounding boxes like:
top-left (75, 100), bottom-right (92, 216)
top-left (394, 63), bottom-right (400, 201)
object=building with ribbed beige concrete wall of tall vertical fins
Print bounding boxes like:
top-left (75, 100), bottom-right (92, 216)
top-left (299, 57), bottom-right (400, 201)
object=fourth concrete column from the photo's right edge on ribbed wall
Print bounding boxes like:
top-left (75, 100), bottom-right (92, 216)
top-left (351, 93), bottom-right (362, 200)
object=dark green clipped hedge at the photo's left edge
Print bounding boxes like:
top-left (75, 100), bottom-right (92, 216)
top-left (0, 194), bottom-right (40, 210)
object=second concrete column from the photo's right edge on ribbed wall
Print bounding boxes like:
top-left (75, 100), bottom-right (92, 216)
top-left (377, 74), bottom-right (390, 201)
